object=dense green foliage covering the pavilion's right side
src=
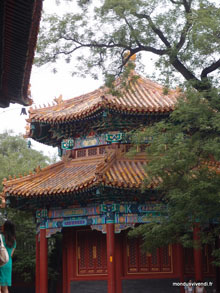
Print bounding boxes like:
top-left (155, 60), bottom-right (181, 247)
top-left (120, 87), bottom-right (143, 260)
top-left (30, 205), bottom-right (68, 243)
top-left (131, 88), bottom-right (220, 262)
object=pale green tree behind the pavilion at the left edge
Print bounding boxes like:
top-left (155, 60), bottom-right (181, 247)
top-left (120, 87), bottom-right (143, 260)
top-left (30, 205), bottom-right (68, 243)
top-left (0, 132), bottom-right (54, 282)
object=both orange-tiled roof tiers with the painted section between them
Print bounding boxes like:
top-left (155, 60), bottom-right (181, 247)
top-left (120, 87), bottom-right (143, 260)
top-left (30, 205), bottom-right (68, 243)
top-left (3, 77), bottom-right (179, 206)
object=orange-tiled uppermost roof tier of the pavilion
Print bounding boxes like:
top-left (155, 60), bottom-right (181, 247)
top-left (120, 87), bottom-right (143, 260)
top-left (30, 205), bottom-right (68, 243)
top-left (28, 77), bottom-right (179, 124)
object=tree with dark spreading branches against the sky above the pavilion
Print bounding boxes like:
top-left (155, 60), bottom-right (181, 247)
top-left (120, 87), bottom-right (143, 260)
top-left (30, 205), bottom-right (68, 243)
top-left (36, 0), bottom-right (220, 91)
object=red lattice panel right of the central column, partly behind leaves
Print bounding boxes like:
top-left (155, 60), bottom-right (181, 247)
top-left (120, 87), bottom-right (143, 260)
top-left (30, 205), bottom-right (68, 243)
top-left (127, 239), bottom-right (172, 273)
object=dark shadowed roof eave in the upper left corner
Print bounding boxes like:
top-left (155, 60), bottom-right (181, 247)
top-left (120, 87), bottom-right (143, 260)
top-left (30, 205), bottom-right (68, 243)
top-left (0, 0), bottom-right (43, 107)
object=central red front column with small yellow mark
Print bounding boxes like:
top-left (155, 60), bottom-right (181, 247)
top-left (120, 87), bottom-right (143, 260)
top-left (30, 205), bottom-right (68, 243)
top-left (106, 223), bottom-right (116, 293)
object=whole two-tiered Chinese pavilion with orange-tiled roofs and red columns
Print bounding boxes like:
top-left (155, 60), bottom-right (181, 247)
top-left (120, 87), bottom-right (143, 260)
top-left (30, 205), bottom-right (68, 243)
top-left (3, 77), bottom-right (214, 293)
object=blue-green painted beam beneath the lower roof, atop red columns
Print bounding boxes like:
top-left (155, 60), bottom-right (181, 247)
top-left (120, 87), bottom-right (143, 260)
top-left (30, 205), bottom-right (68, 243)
top-left (36, 203), bottom-right (164, 230)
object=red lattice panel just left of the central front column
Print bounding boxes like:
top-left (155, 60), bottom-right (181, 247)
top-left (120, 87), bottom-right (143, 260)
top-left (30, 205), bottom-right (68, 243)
top-left (77, 231), bottom-right (107, 275)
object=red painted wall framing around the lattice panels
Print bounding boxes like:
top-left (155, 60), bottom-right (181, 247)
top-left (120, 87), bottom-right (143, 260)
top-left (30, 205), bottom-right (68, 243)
top-left (63, 227), bottom-right (214, 293)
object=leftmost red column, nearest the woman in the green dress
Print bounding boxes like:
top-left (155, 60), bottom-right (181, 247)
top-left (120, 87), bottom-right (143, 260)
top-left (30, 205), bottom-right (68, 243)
top-left (39, 229), bottom-right (48, 293)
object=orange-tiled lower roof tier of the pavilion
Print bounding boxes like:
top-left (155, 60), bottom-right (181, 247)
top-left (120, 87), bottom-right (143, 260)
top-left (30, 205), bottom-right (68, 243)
top-left (3, 151), bottom-right (156, 199)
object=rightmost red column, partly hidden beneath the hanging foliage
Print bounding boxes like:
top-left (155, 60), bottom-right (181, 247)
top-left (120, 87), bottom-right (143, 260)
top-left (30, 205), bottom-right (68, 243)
top-left (193, 223), bottom-right (203, 281)
